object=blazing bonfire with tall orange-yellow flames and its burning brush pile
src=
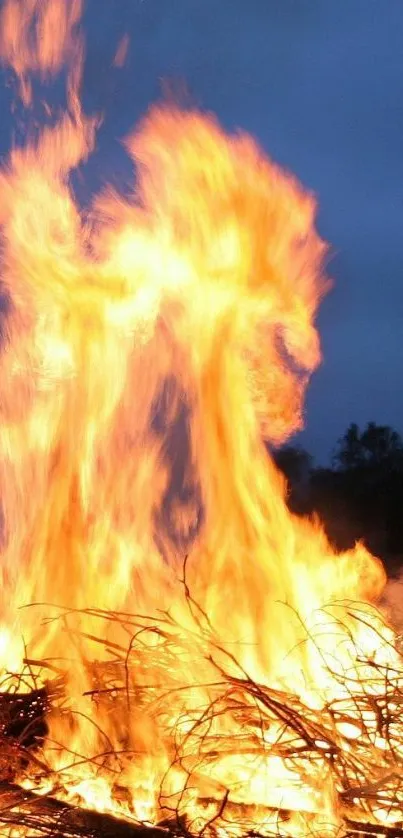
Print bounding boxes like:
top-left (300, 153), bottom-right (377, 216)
top-left (0, 0), bottom-right (403, 838)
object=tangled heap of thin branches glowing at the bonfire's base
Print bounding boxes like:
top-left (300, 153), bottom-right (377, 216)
top-left (0, 589), bottom-right (403, 838)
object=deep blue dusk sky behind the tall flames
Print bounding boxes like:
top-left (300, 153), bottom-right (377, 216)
top-left (0, 0), bottom-right (403, 462)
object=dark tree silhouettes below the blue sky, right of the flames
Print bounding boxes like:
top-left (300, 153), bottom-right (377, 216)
top-left (273, 422), bottom-right (403, 572)
